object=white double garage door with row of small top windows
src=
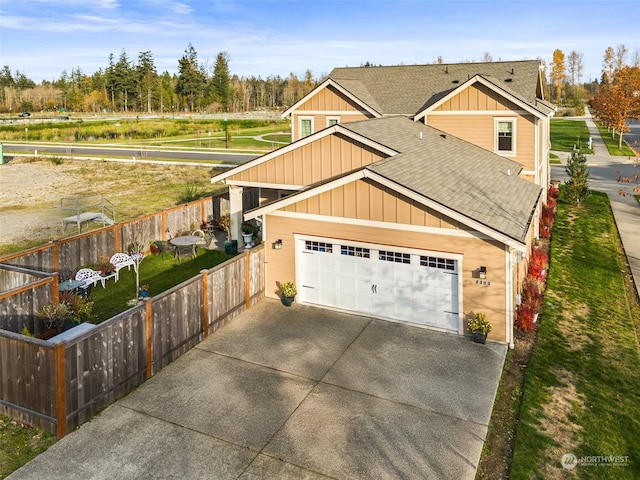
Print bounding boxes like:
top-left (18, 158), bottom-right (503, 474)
top-left (297, 238), bottom-right (458, 332)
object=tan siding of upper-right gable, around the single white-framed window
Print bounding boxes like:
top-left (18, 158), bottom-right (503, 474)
top-left (426, 85), bottom-right (536, 173)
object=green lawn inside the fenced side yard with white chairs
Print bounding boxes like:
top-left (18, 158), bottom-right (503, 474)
top-left (89, 249), bottom-right (231, 323)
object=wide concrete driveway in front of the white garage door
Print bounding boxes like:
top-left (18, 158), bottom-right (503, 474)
top-left (9, 299), bottom-right (506, 480)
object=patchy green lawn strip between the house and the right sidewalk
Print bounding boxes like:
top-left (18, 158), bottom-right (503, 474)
top-left (510, 192), bottom-right (640, 480)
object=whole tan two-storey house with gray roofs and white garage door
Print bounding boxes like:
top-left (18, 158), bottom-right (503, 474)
top-left (212, 62), bottom-right (553, 344)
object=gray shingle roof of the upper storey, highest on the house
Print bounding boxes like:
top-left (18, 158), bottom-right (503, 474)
top-left (329, 60), bottom-right (540, 115)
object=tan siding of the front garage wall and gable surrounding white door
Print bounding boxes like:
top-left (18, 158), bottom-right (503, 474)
top-left (266, 181), bottom-right (506, 341)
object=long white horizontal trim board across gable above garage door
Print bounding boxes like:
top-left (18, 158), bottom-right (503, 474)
top-left (264, 210), bottom-right (491, 243)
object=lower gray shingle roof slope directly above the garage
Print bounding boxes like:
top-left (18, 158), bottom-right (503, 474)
top-left (340, 116), bottom-right (542, 242)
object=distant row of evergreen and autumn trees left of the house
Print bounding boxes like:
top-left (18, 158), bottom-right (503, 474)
top-left (0, 44), bottom-right (317, 113)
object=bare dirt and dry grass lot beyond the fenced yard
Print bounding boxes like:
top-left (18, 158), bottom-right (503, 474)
top-left (0, 157), bottom-right (221, 253)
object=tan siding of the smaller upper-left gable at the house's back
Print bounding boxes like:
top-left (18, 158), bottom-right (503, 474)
top-left (291, 87), bottom-right (372, 140)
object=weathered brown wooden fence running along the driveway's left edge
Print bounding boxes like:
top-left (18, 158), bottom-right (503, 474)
top-left (0, 246), bottom-right (265, 438)
